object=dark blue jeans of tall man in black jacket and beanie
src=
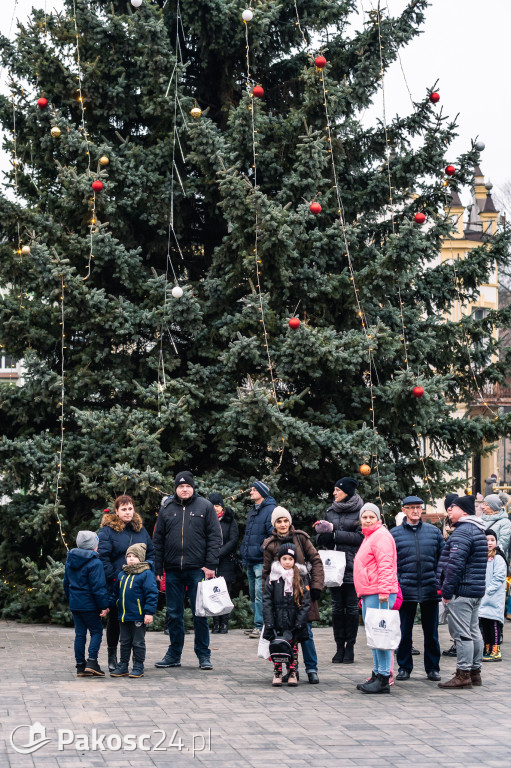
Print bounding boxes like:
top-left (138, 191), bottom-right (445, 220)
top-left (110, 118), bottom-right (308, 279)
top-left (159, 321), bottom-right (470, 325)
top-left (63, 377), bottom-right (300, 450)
top-left (165, 568), bottom-right (211, 661)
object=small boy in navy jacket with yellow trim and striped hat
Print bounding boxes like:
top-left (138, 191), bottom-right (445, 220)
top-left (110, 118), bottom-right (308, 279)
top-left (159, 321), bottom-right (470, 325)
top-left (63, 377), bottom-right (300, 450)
top-left (110, 544), bottom-right (158, 677)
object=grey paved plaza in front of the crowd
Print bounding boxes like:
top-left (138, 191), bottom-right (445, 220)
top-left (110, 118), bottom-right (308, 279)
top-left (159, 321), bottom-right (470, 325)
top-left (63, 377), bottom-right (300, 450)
top-left (0, 622), bottom-right (511, 768)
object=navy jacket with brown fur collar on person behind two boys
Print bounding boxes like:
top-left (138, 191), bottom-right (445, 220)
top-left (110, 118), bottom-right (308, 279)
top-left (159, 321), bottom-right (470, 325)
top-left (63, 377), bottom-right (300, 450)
top-left (98, 512), bottom-right (154, 589)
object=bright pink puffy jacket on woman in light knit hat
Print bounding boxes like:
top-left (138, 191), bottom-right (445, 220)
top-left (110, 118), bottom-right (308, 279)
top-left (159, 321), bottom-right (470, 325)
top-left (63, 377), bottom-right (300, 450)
top-left (353, 520), bottom-right (399, 597)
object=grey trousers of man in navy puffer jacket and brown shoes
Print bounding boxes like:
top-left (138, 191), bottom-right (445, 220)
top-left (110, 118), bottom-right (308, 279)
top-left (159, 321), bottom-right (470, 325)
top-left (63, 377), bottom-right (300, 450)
top-left (447, 597), bottom-right (483, 671)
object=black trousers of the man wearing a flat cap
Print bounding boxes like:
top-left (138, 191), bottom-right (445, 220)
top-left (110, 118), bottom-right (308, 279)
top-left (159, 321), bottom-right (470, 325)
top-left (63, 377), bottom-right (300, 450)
top-left (396, 600), bottom-right (440, 673)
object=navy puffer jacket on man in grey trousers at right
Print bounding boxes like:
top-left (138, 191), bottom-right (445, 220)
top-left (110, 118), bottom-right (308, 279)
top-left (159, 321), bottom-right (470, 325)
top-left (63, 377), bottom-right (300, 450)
top-left (436, 515), bottom-right (488, 600)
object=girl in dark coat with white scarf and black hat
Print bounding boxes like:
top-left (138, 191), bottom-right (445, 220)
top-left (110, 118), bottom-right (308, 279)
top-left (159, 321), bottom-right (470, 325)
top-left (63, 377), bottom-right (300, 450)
top-left (263, 543), bottom-right (310, 686)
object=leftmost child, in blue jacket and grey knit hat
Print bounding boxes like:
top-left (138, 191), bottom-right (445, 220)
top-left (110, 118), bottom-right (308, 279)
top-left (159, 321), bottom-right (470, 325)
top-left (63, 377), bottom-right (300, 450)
top-left (64, 531), bottom-right (110, 677)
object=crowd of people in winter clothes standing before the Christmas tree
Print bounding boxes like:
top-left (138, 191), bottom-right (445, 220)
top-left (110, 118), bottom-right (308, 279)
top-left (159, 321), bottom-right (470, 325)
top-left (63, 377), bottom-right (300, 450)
top-left (64, 471), bottom-right (511, 694)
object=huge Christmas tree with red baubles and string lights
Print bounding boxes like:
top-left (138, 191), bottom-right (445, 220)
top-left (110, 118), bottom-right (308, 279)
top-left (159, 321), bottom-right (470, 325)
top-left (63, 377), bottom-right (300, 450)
top-left (0, 0), bottom-right (509, 618)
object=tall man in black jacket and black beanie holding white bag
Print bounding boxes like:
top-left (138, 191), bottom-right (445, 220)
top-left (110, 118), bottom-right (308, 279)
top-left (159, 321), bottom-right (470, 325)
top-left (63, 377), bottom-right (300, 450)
top-left (153, 472), bottom-right (222, 669)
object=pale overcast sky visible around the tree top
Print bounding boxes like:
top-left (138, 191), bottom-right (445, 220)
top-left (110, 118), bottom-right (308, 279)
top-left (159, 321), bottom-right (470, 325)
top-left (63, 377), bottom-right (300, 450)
top-left (0, 0), bottom-right (511, 202)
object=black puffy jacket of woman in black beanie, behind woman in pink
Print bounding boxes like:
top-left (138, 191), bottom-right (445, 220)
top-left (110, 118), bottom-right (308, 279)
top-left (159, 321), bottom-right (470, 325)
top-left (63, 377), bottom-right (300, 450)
top-left (316, 493), bottom-right (364, 584)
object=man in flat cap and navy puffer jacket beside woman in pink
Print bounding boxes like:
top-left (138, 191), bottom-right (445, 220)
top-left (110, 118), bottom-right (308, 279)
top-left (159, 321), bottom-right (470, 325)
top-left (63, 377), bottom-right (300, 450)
top-left (391, 496), bottom-right (444, 681)
